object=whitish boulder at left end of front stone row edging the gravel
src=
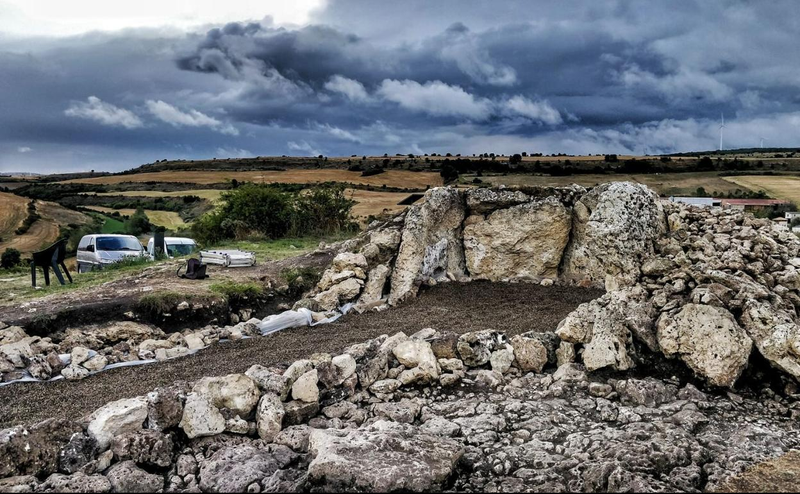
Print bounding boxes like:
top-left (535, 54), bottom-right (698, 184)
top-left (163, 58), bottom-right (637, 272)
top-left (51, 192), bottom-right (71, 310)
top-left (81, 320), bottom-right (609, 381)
top-left (86, 397), bottom-right (147, 451)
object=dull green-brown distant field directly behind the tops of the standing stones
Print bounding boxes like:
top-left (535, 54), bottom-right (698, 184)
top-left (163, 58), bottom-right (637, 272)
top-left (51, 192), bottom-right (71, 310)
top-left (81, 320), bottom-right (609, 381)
top-left (472, 172), bottom-right (760, 196)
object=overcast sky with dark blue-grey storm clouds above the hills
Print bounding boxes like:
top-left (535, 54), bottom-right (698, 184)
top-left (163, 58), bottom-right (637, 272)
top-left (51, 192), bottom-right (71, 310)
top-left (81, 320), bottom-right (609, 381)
top-left (0, 0), bottom-right (800, 172)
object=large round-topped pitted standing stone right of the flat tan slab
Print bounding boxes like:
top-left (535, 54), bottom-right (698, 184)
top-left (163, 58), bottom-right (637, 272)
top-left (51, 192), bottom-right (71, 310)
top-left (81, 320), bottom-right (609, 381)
top-left (563, 182), bottom-right (667, 291)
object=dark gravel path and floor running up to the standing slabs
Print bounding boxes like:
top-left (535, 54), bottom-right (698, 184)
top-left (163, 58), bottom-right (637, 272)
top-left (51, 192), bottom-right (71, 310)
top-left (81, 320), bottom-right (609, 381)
top-left (0, 282), bottom-right (602, 427)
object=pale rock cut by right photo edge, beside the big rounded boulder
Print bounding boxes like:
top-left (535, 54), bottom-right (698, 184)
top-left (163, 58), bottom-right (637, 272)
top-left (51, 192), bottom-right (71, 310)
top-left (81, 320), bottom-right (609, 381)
top-left (741, 300), bottom-right (800, 379)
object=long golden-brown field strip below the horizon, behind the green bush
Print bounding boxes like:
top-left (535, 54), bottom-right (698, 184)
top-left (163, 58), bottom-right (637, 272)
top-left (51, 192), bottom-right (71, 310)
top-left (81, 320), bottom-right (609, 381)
top-left (63, 169), bottom-right (442, 189)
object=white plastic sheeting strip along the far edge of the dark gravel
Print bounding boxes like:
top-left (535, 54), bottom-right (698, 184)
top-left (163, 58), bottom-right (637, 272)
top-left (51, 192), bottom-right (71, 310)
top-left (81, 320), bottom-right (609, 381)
top-left (0, 303), bottom-right (354, 387)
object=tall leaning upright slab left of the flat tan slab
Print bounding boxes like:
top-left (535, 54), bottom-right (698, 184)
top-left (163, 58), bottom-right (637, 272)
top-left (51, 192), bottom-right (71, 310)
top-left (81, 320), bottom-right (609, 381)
top-left (389, 187), bottom-right (465, 305)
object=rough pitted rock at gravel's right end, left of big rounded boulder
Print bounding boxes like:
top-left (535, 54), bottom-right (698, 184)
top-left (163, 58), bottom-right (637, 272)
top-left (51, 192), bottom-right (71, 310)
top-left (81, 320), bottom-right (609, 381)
top-left (556, 286), bottom-right (658, 371)
